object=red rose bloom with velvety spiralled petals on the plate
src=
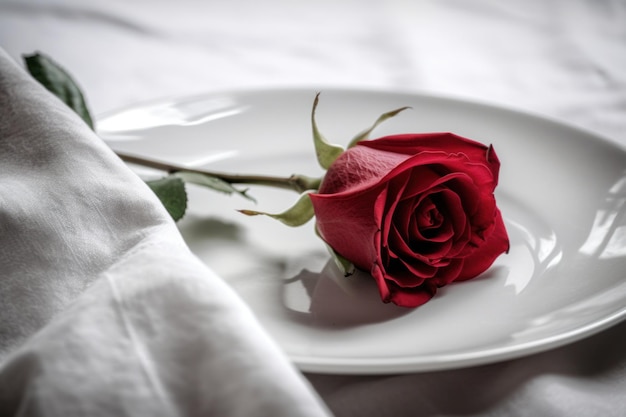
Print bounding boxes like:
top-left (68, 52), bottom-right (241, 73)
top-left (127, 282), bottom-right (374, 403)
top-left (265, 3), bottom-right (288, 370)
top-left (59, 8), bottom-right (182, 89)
top-left (310, 133), bottom-right (509, 307)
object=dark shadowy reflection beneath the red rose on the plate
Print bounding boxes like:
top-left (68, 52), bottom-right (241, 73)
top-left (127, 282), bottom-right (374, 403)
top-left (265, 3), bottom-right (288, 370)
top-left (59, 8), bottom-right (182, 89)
top-left (282, 261), bottom-right (412, 329)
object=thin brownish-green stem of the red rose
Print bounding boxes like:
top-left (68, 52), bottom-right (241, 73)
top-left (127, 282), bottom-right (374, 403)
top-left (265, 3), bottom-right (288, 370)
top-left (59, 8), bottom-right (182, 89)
top-left (116, 151), bottom-right (320, 193)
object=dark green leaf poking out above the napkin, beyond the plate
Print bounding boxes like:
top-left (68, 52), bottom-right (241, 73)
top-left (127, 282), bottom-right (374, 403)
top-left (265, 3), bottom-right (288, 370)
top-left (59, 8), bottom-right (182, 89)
top-left (24, 53), bottom-right (94, 130)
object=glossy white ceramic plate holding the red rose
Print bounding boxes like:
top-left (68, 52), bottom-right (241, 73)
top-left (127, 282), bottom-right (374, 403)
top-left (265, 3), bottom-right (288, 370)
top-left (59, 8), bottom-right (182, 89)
top-left (99, 90), bottom-right (626, 374)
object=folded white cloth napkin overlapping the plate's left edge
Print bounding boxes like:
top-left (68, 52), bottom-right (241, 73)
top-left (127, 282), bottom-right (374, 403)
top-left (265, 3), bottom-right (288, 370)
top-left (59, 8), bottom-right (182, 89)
top-left (0, 50), bottom-right (327, 417)
